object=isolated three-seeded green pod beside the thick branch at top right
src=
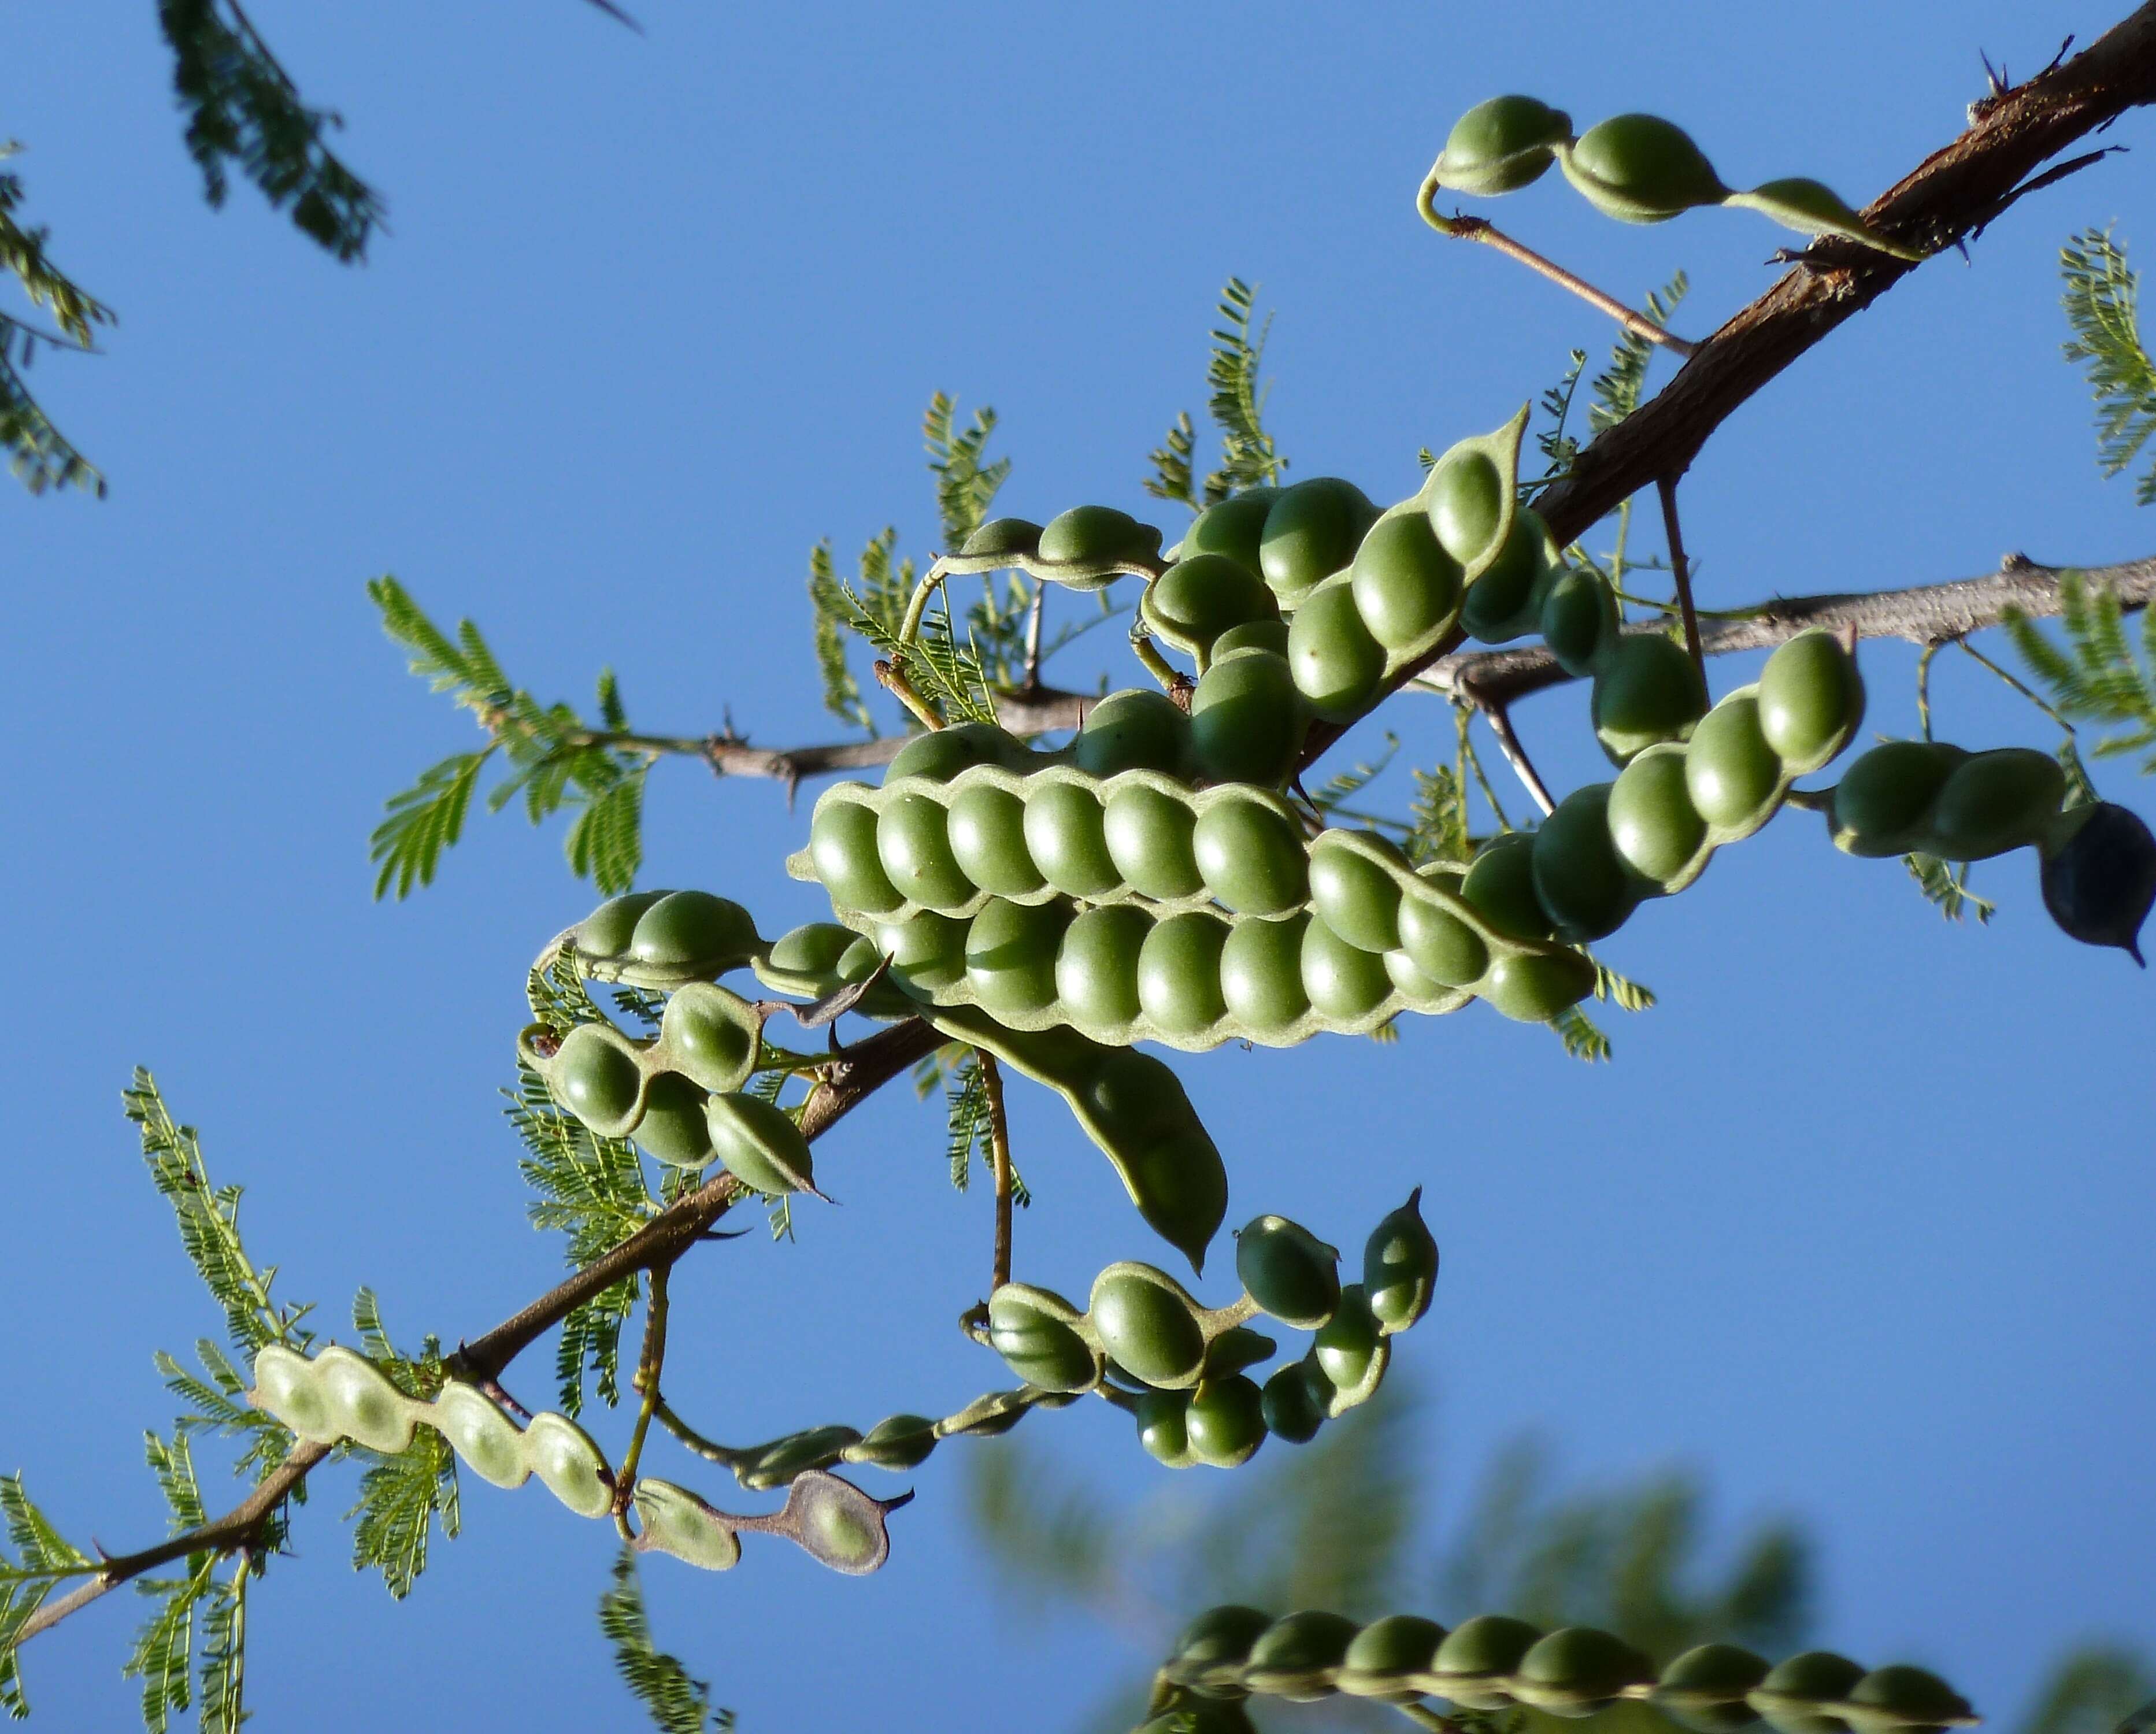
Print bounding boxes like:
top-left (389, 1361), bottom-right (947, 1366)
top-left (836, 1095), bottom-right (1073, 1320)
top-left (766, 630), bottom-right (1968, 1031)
top-left (1423, 95), bottom-right (1923, 261)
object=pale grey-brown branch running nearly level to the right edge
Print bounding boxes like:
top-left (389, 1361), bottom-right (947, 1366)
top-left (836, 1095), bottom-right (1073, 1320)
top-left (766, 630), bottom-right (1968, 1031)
top-left (1414, 554), bottom-right (2156, 707)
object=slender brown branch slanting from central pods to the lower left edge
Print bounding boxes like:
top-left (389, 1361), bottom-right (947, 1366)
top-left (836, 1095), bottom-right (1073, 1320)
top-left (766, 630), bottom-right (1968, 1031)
top-left (15, 1018), bottom-right (942, 1646)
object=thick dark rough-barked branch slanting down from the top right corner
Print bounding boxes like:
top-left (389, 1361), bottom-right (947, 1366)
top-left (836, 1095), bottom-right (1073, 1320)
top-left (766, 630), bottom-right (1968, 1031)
top-left (1537, 0), bottom-right (2156, 543)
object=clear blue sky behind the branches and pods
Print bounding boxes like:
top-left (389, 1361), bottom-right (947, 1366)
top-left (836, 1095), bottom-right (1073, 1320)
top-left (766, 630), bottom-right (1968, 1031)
top-left (0, 0), bottom-right (2156, 1734)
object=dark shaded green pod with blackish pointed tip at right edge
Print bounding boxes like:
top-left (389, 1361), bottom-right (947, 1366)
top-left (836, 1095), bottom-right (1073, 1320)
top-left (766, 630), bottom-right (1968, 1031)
top-left (1826, 740), bottom-right (2156, 964)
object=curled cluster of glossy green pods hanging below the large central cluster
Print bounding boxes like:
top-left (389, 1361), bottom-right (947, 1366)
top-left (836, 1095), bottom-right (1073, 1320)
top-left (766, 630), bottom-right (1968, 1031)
top-left (987, 1188), bottom-right (1438, 1469)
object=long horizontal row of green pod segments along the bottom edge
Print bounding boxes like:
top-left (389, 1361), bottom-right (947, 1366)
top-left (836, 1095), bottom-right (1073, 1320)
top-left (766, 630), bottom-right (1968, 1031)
top-left (1151, 1605), bottom-right (1977, 1734)
